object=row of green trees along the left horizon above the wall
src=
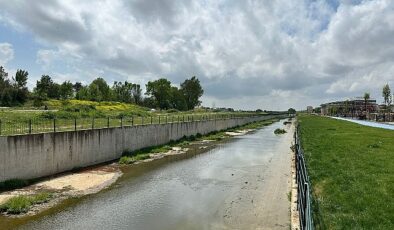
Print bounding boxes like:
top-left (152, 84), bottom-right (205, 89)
top-left (0, 66), bottom-right (204, 111)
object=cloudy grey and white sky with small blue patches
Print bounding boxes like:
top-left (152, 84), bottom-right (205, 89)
top-left (0, 0), bottom-right (394, 110)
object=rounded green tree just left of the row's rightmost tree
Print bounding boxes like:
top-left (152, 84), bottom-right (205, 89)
top-left (145, 78), bottom-right (171, 109)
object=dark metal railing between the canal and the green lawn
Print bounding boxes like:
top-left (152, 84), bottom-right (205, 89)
top-left (294, 126), bottom-right (314, 230)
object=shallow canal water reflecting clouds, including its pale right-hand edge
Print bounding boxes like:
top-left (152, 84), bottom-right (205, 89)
top-left (14, 121), bottom-right (293, 230)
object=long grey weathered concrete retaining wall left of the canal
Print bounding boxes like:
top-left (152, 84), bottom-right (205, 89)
top-left (0, 115), bottom-right (285, 181)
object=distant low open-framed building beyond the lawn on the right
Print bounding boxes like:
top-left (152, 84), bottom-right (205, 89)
top-left (321, 97), bottom-right (379, 119)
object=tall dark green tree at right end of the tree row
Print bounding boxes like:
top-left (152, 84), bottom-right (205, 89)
top-left (181, 76), bottom-right (204, 110)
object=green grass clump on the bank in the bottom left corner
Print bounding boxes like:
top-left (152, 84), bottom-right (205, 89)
top-left (0, 192), bottom-right (52, 214)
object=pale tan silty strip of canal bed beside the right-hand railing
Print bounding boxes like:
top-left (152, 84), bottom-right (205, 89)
top-left (223, 124), bottom-right (294, 229)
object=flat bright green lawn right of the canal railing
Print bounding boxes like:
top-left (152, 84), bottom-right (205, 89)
top-left (298, 115), bottom-right (394, 229)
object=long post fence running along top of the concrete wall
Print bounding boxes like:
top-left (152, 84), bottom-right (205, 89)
top-left (0, 113), bottom-right (261, 136)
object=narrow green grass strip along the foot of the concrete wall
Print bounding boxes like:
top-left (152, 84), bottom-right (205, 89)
top-left (119, 119), bottom-right (279, 164)
